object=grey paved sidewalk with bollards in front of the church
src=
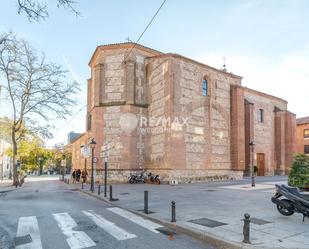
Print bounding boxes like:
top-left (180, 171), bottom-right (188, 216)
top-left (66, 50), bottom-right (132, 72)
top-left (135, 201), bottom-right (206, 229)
top-left (67, 177), bottom-right (309, 249)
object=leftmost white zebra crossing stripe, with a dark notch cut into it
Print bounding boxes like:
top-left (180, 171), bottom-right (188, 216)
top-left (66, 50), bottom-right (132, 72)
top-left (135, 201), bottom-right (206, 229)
top-left (15, 216), bottom-right (42, 249)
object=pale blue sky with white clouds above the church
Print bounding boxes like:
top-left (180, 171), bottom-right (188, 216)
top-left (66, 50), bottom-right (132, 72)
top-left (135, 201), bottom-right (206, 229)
top-left (0, 0), bottom-right (309, 146)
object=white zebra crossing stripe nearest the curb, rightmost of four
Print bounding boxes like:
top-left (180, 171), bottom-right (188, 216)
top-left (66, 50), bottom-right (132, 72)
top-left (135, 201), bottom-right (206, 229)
top-left (107, 207), bottom-right (163, 233)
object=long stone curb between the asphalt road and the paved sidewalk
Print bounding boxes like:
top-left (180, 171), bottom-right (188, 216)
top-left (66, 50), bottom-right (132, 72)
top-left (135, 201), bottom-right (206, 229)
top-left (75, 188), bottom-right (245, 249)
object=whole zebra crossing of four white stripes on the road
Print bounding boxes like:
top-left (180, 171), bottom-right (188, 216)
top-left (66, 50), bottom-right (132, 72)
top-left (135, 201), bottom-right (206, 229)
top-left (15, 207), bottom-right (162, 249)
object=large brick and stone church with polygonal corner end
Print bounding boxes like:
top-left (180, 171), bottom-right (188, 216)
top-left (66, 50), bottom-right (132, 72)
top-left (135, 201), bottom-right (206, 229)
top-left (71, 43), bottom-right (296, 182)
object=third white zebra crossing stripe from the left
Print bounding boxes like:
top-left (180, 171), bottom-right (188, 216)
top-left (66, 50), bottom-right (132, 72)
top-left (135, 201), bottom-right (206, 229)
top-left (83, 210), bottom-right (136, 240)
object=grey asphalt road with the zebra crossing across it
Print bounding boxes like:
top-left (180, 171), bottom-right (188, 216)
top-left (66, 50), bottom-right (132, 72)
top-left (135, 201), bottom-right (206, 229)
top-left (0, 179), bottom-right (213, 249)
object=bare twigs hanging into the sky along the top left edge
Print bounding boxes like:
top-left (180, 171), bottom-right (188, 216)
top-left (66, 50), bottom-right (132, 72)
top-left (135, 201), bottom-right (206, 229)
top-left (17, 0), bottom-right (80, 21)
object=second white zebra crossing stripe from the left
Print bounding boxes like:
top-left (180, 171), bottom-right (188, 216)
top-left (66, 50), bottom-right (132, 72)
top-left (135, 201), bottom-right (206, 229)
top-left (53, 213), bottom-right (96, 249)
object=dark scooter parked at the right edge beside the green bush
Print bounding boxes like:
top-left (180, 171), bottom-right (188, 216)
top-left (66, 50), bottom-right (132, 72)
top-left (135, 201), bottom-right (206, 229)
top-left (271, 185), bottom-right (309, 221)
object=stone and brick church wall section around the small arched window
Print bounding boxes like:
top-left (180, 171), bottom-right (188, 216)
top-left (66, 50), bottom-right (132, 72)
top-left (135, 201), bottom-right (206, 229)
top-left (173, 55), bottom-right (240, 174)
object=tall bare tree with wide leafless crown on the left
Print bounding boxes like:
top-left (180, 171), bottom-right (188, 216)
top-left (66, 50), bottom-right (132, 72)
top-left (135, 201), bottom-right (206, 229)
top-left (0, 33), bottom-right (79, 184)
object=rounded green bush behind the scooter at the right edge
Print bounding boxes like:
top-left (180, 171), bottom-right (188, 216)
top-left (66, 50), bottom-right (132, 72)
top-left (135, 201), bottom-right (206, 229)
top-left (289, 154), bottom-right (309, 188)
